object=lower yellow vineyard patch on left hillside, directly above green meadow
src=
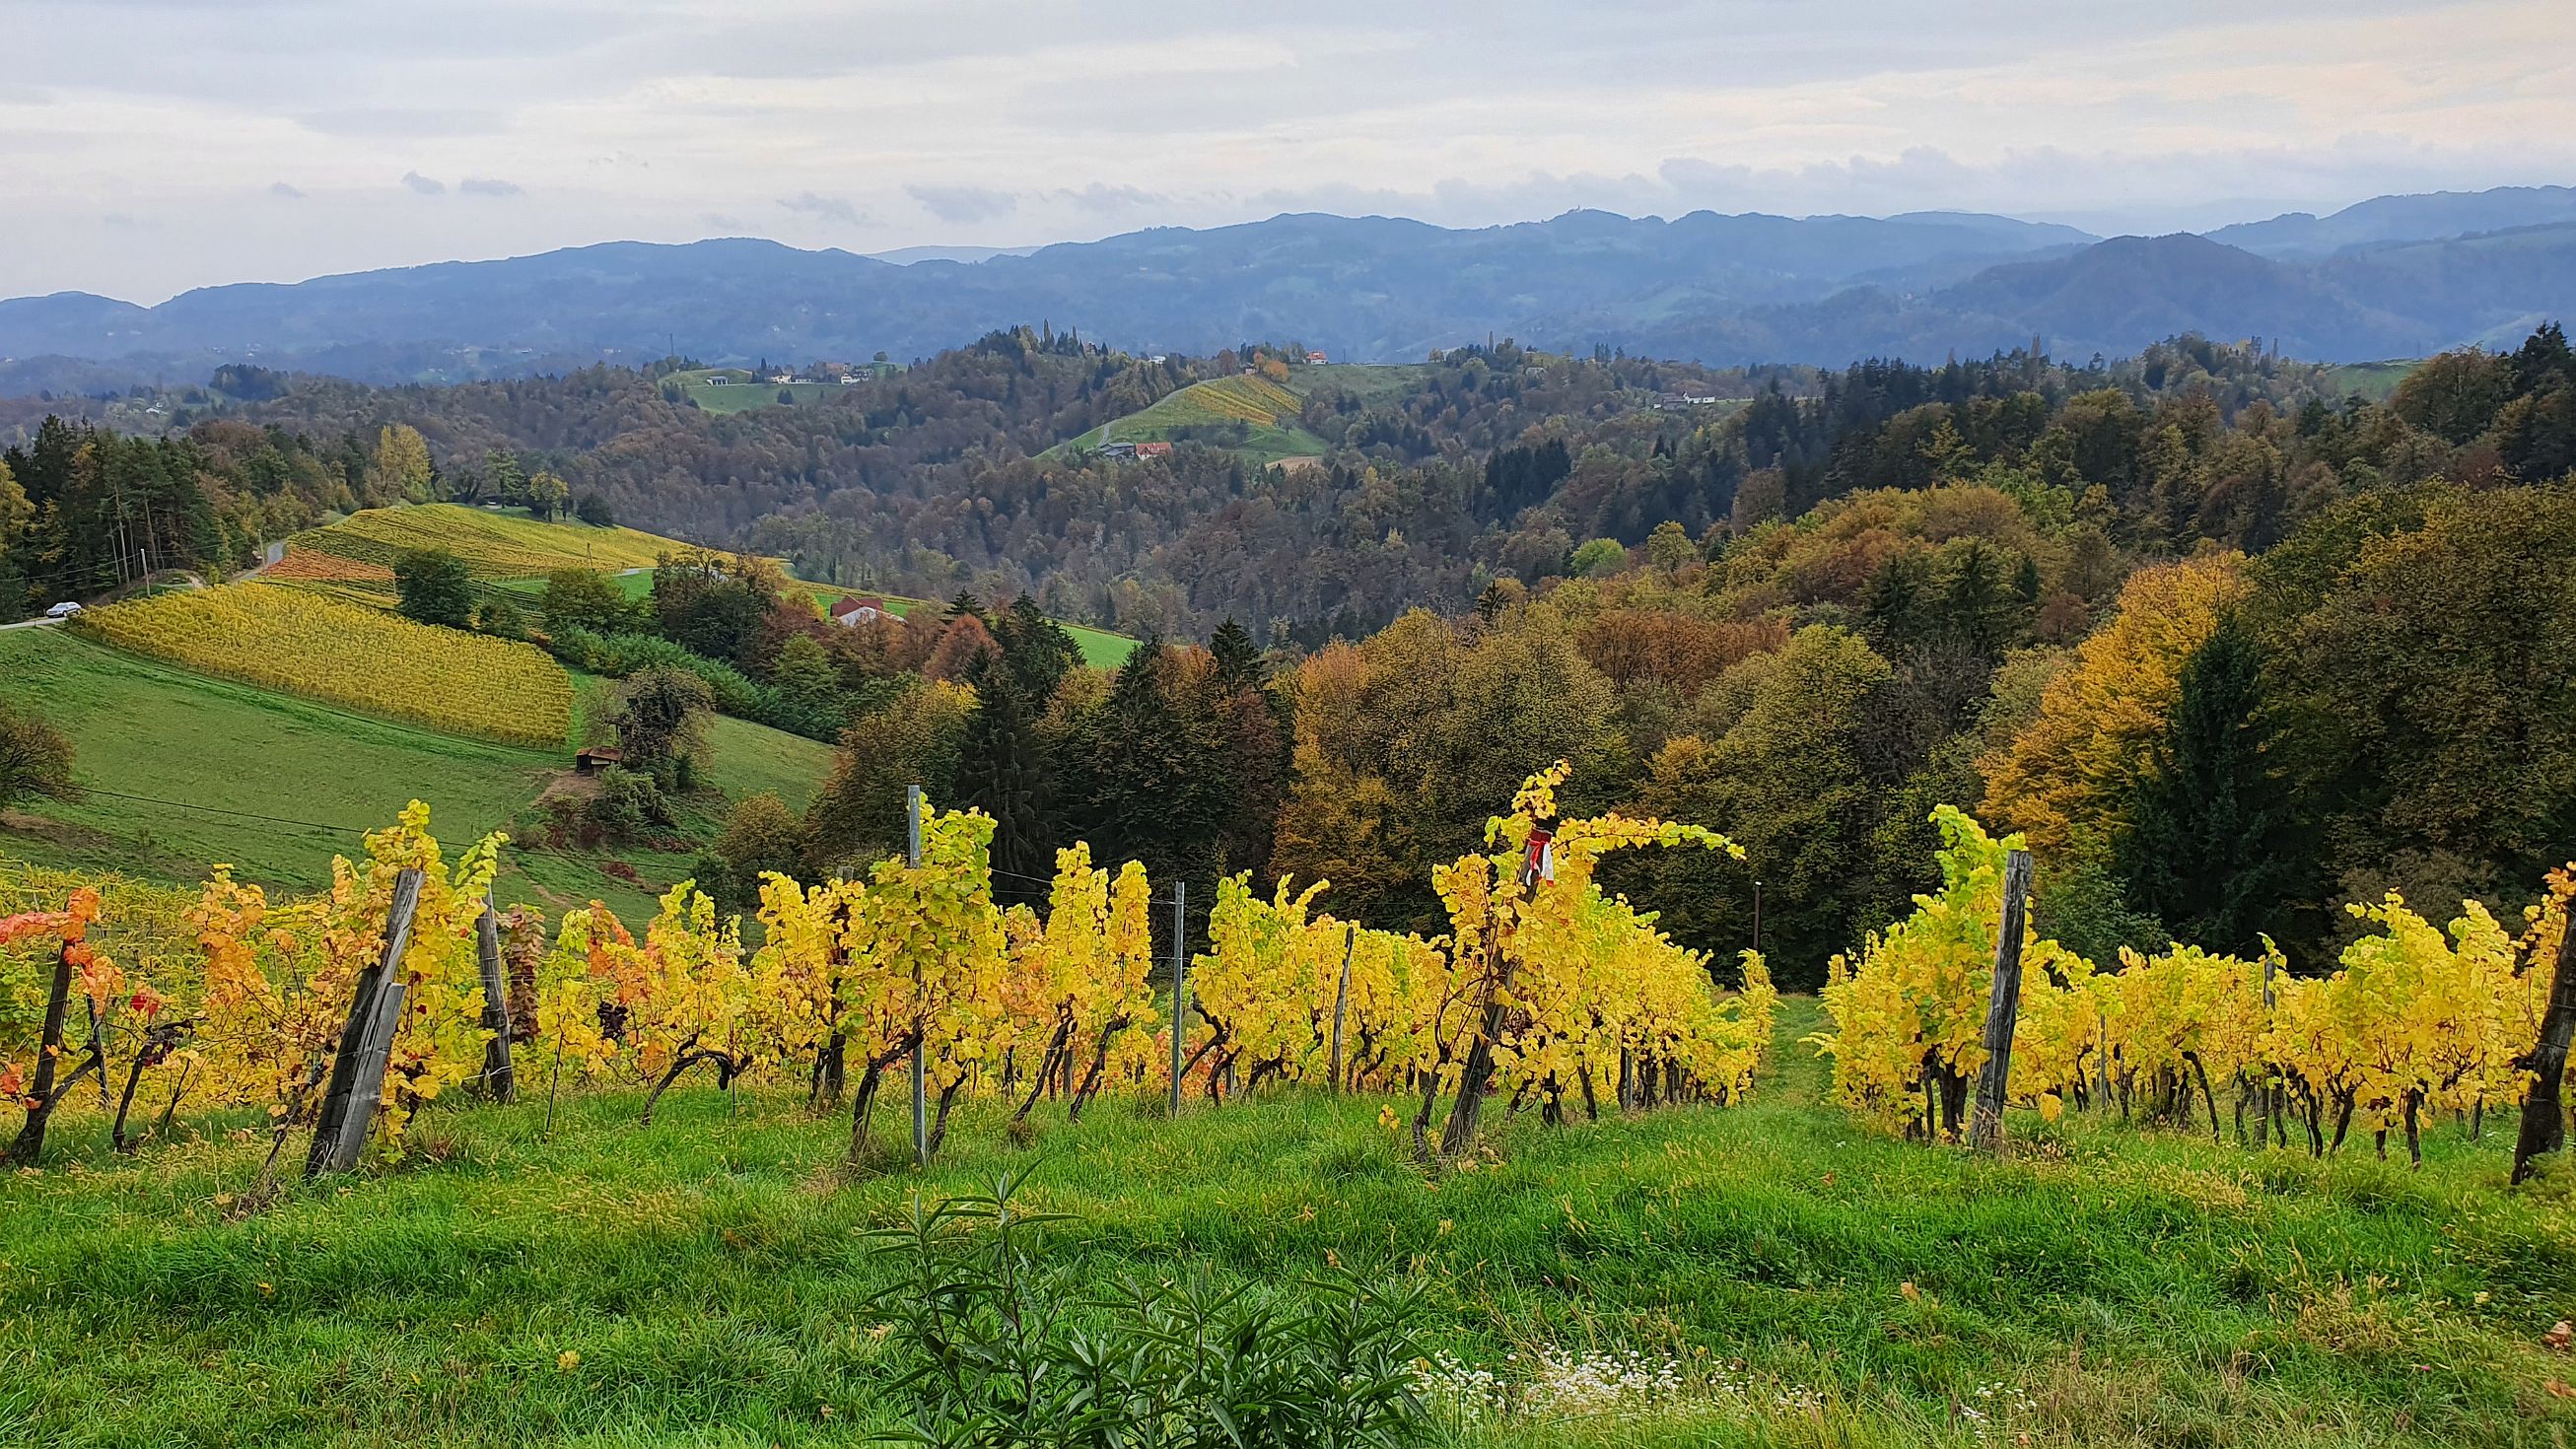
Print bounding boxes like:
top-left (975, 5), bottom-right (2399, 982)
top-left (80, 585), bottom-right (572, 749)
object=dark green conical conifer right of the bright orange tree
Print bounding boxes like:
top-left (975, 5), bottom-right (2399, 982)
top-left (2113, 615), bottom-right (2293, 949)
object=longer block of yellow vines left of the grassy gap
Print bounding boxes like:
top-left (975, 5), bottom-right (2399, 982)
top-left (0, 767), bottom-right (1775, 1163)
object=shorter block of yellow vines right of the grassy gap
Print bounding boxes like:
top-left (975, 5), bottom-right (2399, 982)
top-left (1811, 805), bottom-right (2576, 1161)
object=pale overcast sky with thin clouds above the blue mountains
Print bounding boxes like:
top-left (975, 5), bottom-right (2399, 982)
top-left (0, 0), bottom-right (2576, 304)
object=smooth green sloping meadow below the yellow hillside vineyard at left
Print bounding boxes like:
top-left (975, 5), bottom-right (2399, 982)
top-left (0, 628), bottom-right (832, 919)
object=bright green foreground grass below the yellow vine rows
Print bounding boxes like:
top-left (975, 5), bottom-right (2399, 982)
top-left (0, 999), bottom-right (2576, 1449)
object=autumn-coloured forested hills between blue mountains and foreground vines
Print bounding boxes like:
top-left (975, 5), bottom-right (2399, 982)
top-left (8, 327), bottom-right (2576, 981)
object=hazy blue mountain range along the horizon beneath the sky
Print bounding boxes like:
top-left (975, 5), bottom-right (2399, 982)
top-left (0, 188), bottom-right (2576, 393)
